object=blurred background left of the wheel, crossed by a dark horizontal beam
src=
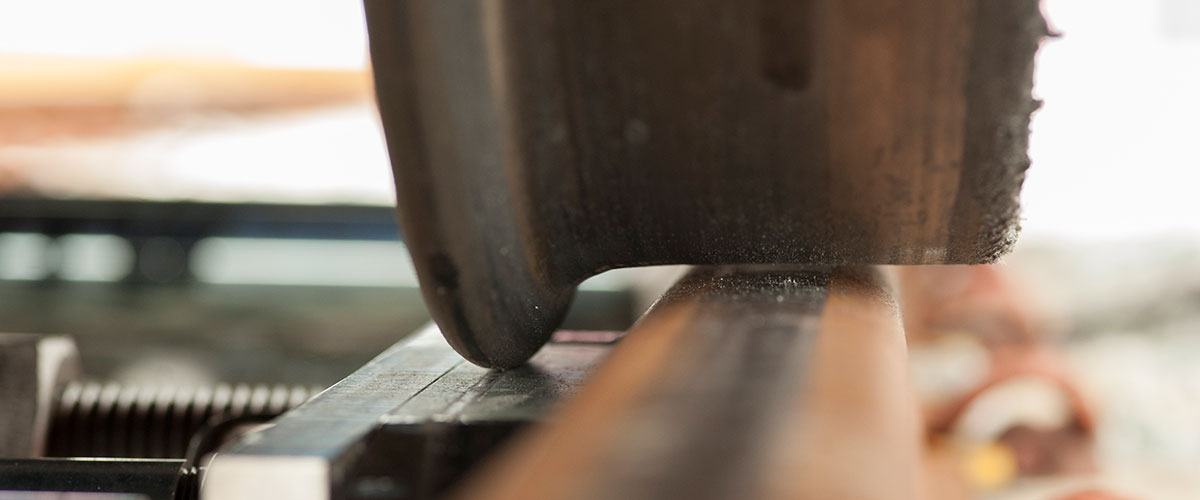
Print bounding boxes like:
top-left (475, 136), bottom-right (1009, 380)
top-left (0, 0), bottom-right (648, 385)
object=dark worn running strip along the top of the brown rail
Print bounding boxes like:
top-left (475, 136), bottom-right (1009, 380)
top-left (578, 264), bottom-right (829, 500)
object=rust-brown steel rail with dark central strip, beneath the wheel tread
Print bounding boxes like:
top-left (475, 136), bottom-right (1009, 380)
top-left (458, 265), bottom-right (923, 500)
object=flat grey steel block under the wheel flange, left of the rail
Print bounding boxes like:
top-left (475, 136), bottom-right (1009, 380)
top-left (202, 325), bottom-right (613, 500)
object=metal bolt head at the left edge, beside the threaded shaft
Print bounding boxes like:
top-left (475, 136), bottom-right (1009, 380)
top-left (0, 333), bottom-right (80, 458)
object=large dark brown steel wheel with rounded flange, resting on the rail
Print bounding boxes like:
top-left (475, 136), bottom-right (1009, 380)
top-left (366, 0), bottom-right (1046, 368)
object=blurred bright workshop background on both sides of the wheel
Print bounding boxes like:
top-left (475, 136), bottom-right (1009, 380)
top-left (0, 0), bottom-right (1200, 499)
